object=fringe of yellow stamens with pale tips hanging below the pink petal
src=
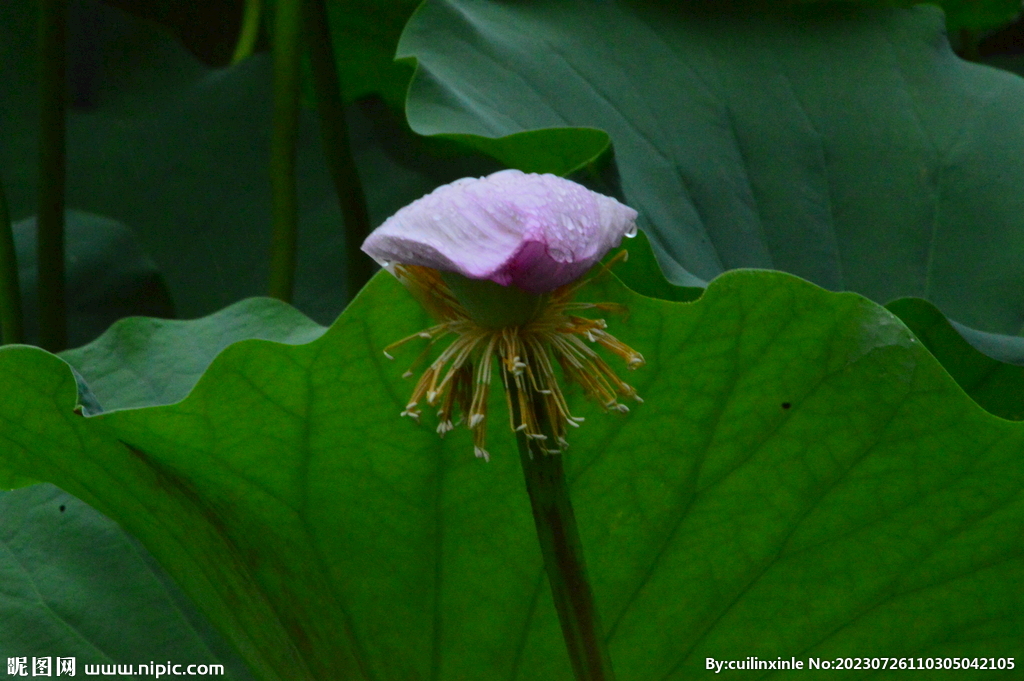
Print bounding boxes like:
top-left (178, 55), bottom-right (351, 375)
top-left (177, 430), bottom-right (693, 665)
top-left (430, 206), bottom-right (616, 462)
top-left (384, 259), bottom-right (644, 460)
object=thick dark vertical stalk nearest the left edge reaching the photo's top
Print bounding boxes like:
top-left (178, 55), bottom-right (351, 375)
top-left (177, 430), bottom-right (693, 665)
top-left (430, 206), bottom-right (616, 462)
top-left (37, 0), bottom-right (68, 352)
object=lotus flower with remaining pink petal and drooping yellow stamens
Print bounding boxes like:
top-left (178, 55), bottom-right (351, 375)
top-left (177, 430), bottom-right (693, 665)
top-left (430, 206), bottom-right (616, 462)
top-left (362, 170), bottom-right (643, 460)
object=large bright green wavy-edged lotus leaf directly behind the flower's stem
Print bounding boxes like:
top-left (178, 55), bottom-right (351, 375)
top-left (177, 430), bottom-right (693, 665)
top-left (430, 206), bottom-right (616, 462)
top-left (0, 271), bottom-right (1024, 681)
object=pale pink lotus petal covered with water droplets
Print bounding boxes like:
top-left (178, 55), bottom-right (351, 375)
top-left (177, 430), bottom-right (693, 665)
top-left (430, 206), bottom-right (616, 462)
top-left (362, 170), bottom-right (637, 293)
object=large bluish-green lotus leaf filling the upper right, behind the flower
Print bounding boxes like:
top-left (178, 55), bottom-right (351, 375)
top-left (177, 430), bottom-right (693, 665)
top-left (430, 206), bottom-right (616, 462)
top-left (398, 0), bottom-right (1024, 334)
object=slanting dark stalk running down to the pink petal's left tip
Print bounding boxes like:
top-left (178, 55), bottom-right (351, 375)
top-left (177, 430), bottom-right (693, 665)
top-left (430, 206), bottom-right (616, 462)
top-left (306, 0), bottom-right (374, 298)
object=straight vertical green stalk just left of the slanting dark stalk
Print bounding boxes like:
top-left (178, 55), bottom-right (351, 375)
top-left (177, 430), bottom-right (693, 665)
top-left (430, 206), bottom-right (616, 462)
top-left (270, 0), bottom-right (302, 302)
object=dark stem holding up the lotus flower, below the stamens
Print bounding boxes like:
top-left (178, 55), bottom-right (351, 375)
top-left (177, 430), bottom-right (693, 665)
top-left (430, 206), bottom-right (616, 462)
top-left (507, 380), bottom-right (615, 681)
